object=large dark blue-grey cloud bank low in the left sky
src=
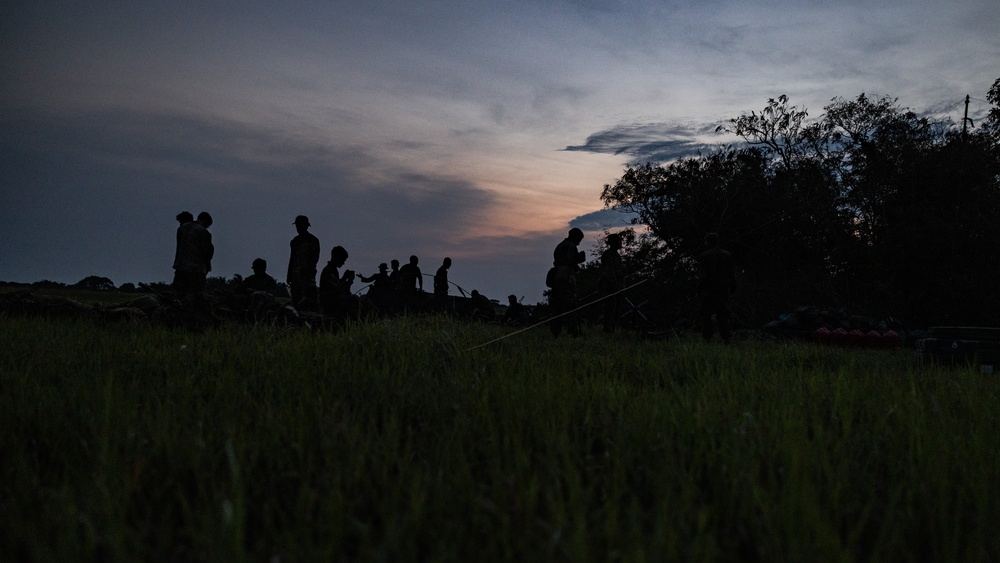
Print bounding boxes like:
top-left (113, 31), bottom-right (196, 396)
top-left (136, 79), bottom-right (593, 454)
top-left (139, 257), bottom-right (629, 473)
top-left (0, 108), bottom-right (496, 290)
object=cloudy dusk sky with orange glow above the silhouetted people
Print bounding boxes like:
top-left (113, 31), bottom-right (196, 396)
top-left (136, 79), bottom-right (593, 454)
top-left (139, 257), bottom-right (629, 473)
top-left (0, 0), bottom-right (1000, 304)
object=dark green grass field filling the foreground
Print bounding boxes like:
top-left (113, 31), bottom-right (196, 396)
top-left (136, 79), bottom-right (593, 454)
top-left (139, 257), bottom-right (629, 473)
top-left (0, 317), bottom-right (1000, 561)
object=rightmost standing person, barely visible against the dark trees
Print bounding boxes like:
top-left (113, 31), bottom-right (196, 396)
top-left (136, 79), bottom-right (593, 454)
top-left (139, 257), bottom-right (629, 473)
top-left (698, 233), bottom-right (736, 344)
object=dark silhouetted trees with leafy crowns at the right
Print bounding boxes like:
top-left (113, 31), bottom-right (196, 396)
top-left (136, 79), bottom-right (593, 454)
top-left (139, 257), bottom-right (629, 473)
top-left (601, 79), bottom-right (1000, 327)
